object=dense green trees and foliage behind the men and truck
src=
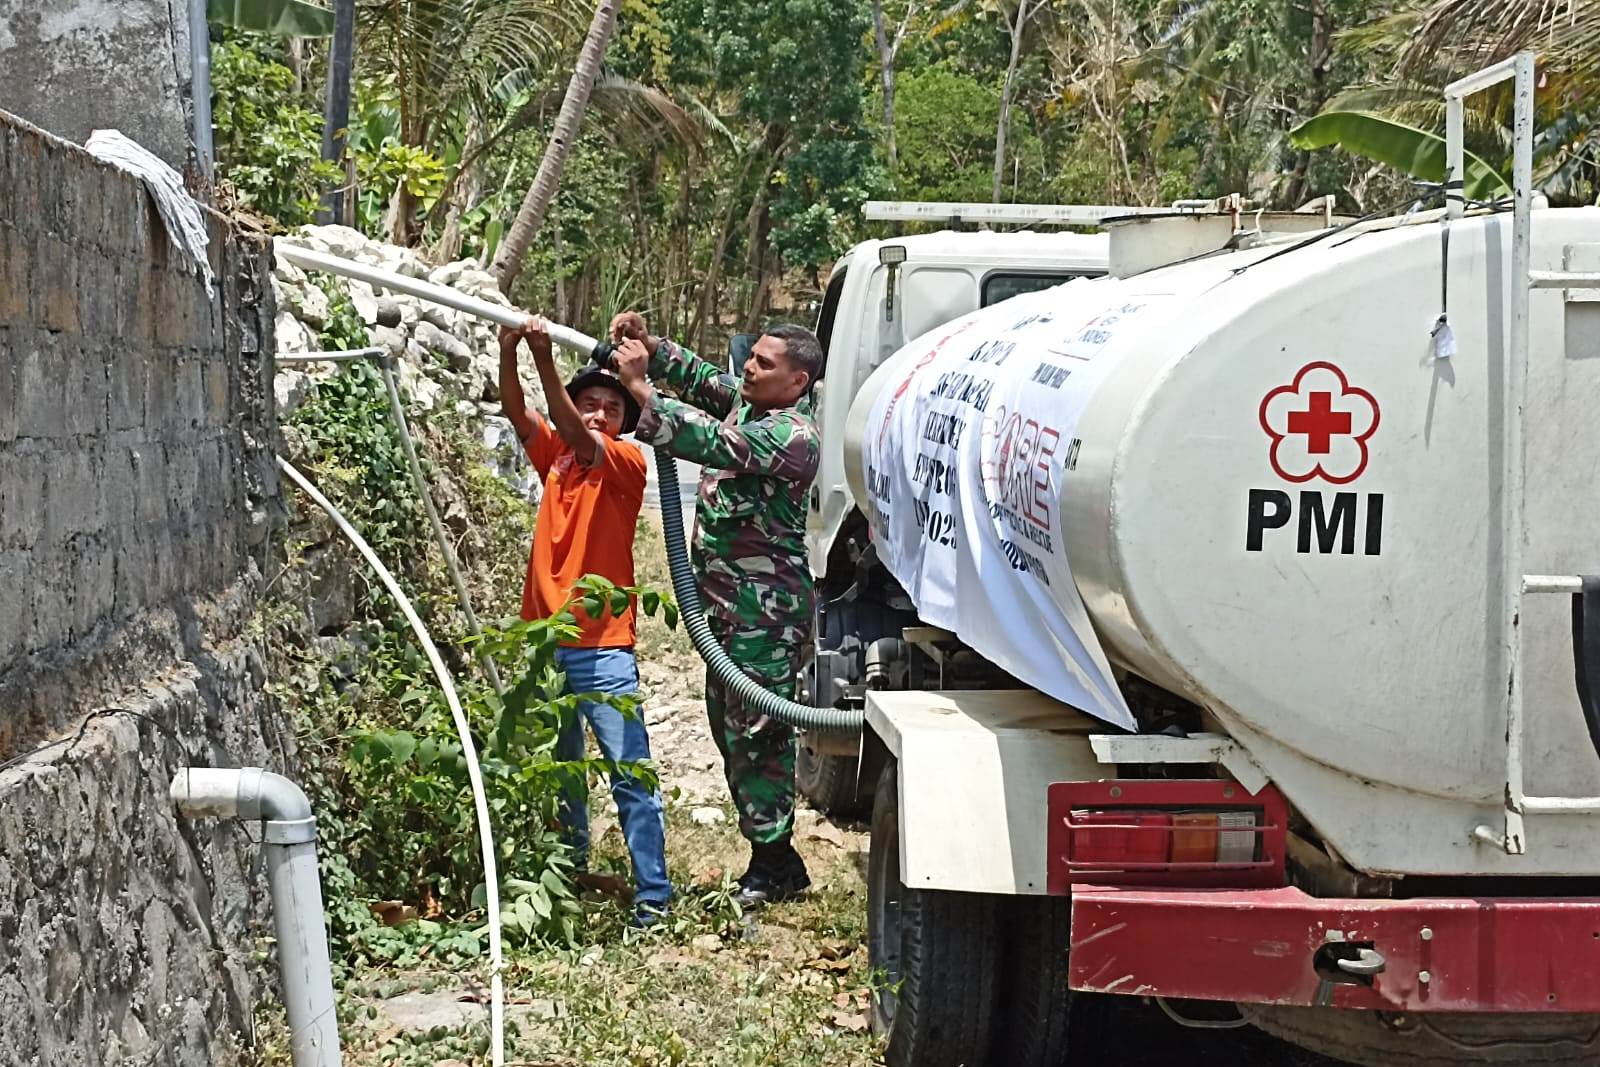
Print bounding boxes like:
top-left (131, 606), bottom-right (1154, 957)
top-left (216, 0), bottom-right (1600, 358)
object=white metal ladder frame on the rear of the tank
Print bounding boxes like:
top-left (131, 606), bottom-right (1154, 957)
top-left (1465, 51), bottom-right (1600, 856)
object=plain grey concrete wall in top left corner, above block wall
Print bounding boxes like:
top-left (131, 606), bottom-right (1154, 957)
top-left (0, 0), bottom-right (196, 171)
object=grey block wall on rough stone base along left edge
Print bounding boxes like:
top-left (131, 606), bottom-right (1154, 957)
top-left (0, 114), bottom-right (286, 1067)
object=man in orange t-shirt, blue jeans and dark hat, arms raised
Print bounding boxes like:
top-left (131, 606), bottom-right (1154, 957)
top-left (499, 315), bottom-right (672, 925)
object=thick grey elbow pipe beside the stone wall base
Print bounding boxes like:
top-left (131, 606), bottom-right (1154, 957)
top-left (171, 766), bottom-right (339, 1067)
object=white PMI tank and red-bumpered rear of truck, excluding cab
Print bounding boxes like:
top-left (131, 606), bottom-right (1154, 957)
top-left (824, 58), bottom-right (1600, 1067)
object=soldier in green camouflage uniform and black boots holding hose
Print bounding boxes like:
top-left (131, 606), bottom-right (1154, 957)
top-left (611, 314), bottom-right (822, 907)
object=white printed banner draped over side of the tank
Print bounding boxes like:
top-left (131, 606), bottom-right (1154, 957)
top-left (864, 282), bottom-right (1163, 728)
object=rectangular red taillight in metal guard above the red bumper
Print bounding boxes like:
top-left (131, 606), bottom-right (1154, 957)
top-left (1046, 779), bottom-right (1288, 893)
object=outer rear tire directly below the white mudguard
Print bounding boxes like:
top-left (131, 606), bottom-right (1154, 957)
top-left (867, 760), bottom-right (998, 1067)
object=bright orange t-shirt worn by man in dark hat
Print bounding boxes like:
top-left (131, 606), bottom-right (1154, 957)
top-left (522, 413), bottom-right (645, 648)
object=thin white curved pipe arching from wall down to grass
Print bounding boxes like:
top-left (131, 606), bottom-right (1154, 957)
top-left (278, 456), bottom-right (506, 1067)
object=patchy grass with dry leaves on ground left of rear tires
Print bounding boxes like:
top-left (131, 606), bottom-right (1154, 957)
top-left (328, 795), bottom-right (882, 1067)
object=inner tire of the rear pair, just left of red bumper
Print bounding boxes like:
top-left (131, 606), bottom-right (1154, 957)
top-left (989, 896), bottom-right (1074, 1067)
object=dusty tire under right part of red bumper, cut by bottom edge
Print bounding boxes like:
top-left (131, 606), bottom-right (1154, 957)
top-left (1238, 1005), bottom-right (1600, 1067)
